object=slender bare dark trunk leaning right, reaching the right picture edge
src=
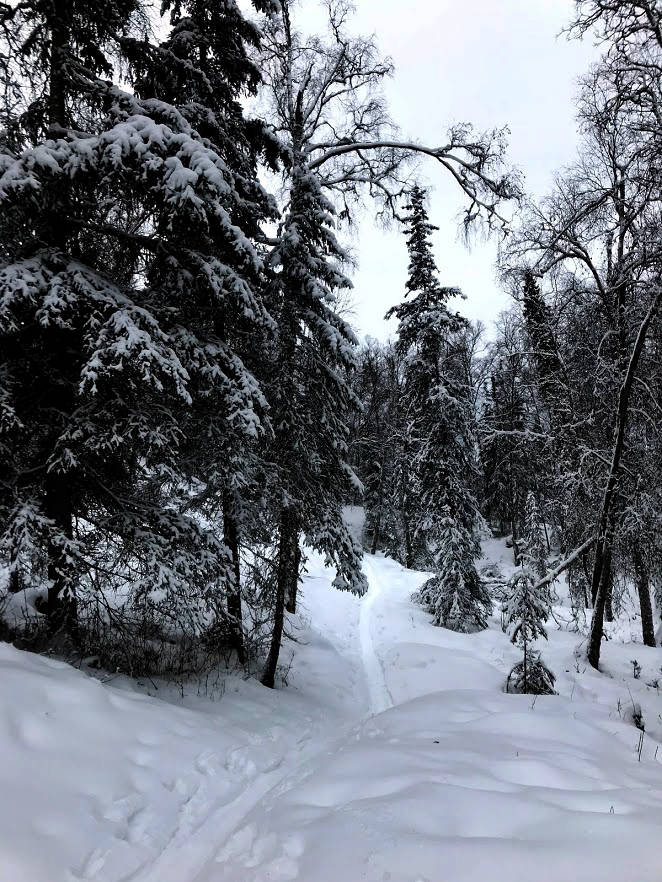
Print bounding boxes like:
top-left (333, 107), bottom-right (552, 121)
top-left (588, 290), bottom-right (662, 668)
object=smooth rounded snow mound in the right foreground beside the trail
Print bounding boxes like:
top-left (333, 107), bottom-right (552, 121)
top-left (214, 690), bottom-right (662, 882)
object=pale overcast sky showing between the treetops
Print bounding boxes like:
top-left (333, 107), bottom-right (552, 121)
top-left (303, 0), bottom-right (596, 339)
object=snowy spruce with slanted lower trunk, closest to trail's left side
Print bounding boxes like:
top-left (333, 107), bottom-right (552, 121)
top-left (262, 163), bottom-right (367, 687)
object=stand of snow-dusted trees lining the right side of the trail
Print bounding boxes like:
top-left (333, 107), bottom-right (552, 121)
top-left (355, 0), bottom-right (662, 667)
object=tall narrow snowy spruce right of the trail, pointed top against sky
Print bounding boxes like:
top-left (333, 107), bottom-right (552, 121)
top-left (388, 186), bottom-right (491, 631)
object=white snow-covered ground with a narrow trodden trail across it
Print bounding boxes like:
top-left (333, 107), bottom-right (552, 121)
top-left (0, 540), bottom-right (662, 882)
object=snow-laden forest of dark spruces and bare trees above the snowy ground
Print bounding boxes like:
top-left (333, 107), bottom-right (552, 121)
top-left (0, 0), bottom-right (662, 882)
